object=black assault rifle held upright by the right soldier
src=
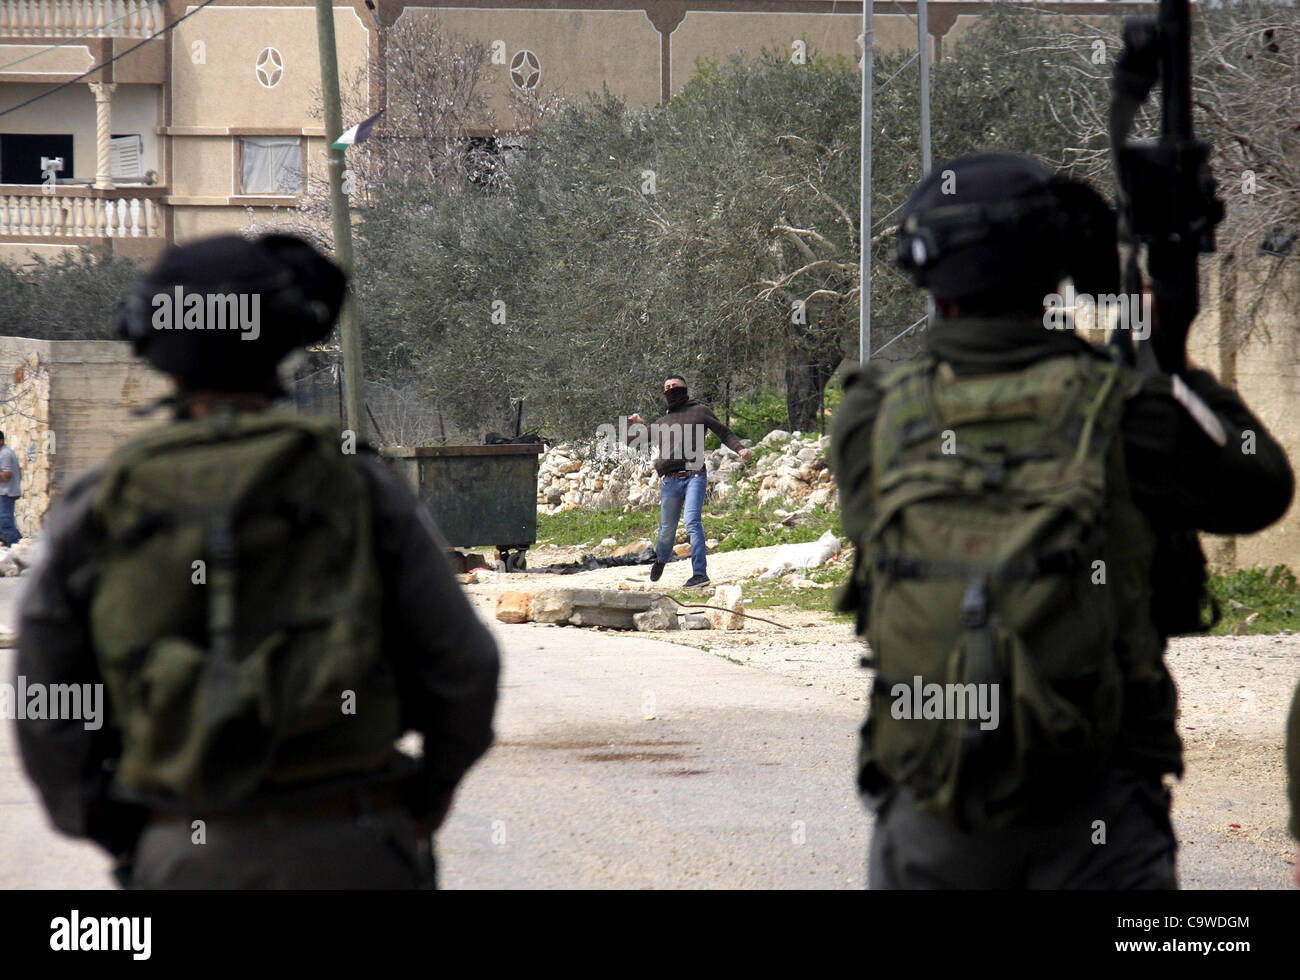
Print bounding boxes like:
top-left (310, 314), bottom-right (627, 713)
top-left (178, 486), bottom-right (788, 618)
top-left (1110, 0), bottom-right (1223, 374)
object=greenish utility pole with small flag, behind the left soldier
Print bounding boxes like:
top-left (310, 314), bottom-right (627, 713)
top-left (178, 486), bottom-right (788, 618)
top-left (308, 0), bottom-right (367, 442)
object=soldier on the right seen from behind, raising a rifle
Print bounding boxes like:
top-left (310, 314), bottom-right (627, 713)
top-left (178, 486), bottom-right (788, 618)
top-left (832, 153), bottom-right (1292, 889)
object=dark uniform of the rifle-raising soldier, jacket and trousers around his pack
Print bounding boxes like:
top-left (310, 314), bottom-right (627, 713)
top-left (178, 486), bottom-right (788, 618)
top-left (832, 317), bottom-right (1292, 888)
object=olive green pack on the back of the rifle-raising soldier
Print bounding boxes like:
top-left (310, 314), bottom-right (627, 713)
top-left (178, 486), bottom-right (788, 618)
top-left (859, 354), bottom-right (1164, 829)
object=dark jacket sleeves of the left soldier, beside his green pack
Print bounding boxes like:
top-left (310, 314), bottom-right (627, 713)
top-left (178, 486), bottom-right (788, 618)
top-left (17, 431), bottom-right (499, 853)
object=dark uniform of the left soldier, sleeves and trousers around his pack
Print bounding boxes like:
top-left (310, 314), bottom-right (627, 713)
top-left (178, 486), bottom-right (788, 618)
top-left (17, 452), bottom-right (499, 888)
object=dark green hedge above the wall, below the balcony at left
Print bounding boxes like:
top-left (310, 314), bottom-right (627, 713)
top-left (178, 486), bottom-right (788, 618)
top-left (0, 248), bottom-right (140, 341)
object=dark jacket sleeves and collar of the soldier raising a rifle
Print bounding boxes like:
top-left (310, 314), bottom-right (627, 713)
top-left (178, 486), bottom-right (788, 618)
top-left (831, 317), bottom-right (1294, 773)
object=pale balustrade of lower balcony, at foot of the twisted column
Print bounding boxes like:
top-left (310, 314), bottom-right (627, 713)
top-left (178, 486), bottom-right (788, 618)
top-left (0, 185), bottom-right (165, 242)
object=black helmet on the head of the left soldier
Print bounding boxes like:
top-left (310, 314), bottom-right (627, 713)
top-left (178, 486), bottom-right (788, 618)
top-left (117, 234), bottom-right (347, 393)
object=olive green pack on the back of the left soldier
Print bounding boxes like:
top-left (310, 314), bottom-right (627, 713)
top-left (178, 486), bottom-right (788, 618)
top-left (90, 411), bottom-right (400, 810)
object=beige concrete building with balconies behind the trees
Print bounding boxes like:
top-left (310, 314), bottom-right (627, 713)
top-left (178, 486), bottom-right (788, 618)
top-left (0, 0), bottom-right (1149, 261)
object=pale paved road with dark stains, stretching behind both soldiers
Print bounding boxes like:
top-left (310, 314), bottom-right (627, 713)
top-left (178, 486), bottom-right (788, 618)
top-left (0, 580), bottom-right (1290, 889)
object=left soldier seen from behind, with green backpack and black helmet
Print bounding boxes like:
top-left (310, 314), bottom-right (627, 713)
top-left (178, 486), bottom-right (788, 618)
top-left (18, 235), bottom-right (498, 888)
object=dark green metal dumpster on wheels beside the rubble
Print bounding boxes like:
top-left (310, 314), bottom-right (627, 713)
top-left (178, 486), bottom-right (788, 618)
top-left (380, 442), bottom-right (545, 572)
